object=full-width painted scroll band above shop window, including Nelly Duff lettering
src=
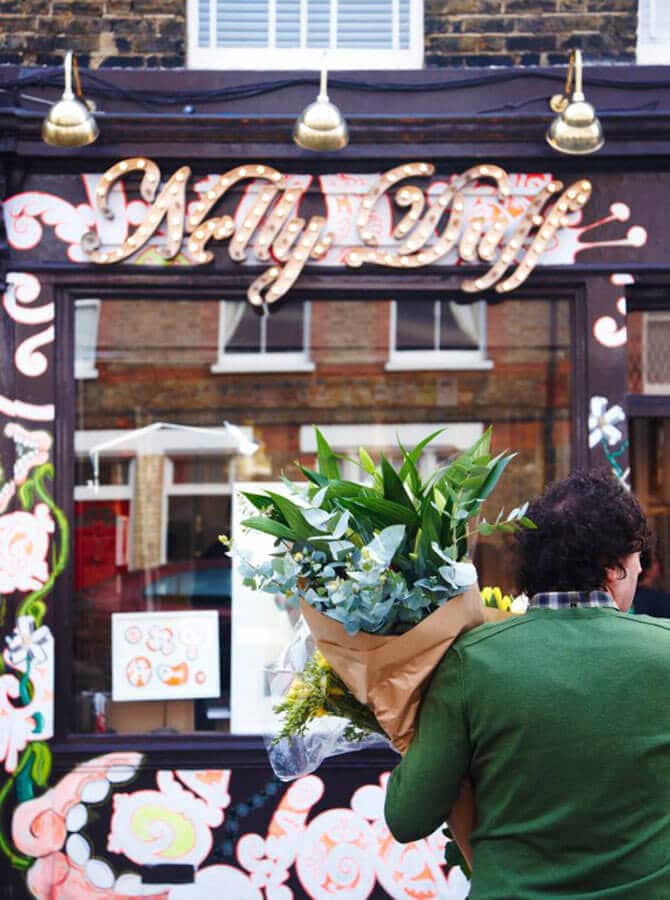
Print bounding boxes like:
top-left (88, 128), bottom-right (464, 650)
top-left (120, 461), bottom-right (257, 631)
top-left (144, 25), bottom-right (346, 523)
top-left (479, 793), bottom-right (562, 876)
top-left (6, 163), bottom-right (646, 307)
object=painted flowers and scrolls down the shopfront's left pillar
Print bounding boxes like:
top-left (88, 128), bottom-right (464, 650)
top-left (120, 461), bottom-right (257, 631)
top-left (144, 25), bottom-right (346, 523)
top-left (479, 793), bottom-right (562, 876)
top-left (0, 274), bottom-right (68, 869)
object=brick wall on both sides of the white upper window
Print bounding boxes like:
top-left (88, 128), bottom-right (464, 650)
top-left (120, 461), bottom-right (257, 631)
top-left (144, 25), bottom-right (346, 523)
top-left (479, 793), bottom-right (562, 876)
top-left (0, 0), bottom-right (637, 68)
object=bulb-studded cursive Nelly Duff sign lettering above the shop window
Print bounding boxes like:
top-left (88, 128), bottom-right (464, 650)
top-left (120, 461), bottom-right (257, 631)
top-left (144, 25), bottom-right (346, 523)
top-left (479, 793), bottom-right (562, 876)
top-left (82, 157), bottom-right (591, 307)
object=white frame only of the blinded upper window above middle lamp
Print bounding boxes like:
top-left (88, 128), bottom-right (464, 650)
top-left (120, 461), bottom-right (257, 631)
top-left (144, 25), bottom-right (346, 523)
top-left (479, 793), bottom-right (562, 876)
top-left (186, 0), bottom-right (424, 71)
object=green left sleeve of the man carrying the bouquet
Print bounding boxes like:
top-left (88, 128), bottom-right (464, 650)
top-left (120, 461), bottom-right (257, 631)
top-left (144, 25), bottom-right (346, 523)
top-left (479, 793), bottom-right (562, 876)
top-left (384, 649), bottom-right (471, 844)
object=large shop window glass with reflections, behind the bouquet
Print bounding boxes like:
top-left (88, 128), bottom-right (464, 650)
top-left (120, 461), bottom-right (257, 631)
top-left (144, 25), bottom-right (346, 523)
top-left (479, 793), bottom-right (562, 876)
top-left (72, 298), bottom-right (572, 734)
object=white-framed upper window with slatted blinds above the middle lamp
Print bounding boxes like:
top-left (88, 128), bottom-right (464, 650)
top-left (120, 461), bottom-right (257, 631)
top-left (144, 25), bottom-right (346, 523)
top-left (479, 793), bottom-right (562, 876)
top-left (187, 0), bottom-right (423, 69)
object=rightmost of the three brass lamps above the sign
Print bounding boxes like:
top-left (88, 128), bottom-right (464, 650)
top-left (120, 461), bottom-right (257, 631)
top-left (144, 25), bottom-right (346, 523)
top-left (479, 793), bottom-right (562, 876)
top-left (546, 50), bottom-right (605, 156)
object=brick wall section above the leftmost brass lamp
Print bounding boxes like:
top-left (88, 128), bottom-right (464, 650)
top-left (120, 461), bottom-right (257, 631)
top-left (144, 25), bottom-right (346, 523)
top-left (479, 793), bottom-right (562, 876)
top-left (0, 0), bottom-right (186, 69)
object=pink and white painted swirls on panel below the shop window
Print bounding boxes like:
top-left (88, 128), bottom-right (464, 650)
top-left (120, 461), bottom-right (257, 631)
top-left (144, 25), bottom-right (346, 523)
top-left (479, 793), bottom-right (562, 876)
top-left (13, 753), bottom-right (468, 900)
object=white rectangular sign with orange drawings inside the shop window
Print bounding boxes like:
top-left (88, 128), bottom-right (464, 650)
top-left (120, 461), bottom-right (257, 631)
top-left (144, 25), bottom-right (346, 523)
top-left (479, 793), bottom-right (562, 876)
top-left (112, 609), bottom-right (221, 701)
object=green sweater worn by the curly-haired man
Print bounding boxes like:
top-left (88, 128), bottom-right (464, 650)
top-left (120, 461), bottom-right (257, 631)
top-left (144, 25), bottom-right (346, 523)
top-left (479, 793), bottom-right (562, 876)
top-left (385, 608), bottom-right (670, 900)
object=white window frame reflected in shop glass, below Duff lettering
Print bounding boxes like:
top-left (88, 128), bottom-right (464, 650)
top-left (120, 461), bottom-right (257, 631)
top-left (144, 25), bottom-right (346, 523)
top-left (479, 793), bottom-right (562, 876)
top-left (385, 300), bottom-right (493, 372)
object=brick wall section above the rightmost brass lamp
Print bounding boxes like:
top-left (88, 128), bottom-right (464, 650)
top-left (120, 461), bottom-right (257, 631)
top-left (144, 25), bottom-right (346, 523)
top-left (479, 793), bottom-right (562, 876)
top-left (425, 0), bottom-right (637, 66)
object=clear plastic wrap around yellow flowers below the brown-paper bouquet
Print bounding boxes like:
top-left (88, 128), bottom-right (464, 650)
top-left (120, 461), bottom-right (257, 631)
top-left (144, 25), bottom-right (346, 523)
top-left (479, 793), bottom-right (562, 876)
top-left (265, 618), bottom-right (391, 781)
